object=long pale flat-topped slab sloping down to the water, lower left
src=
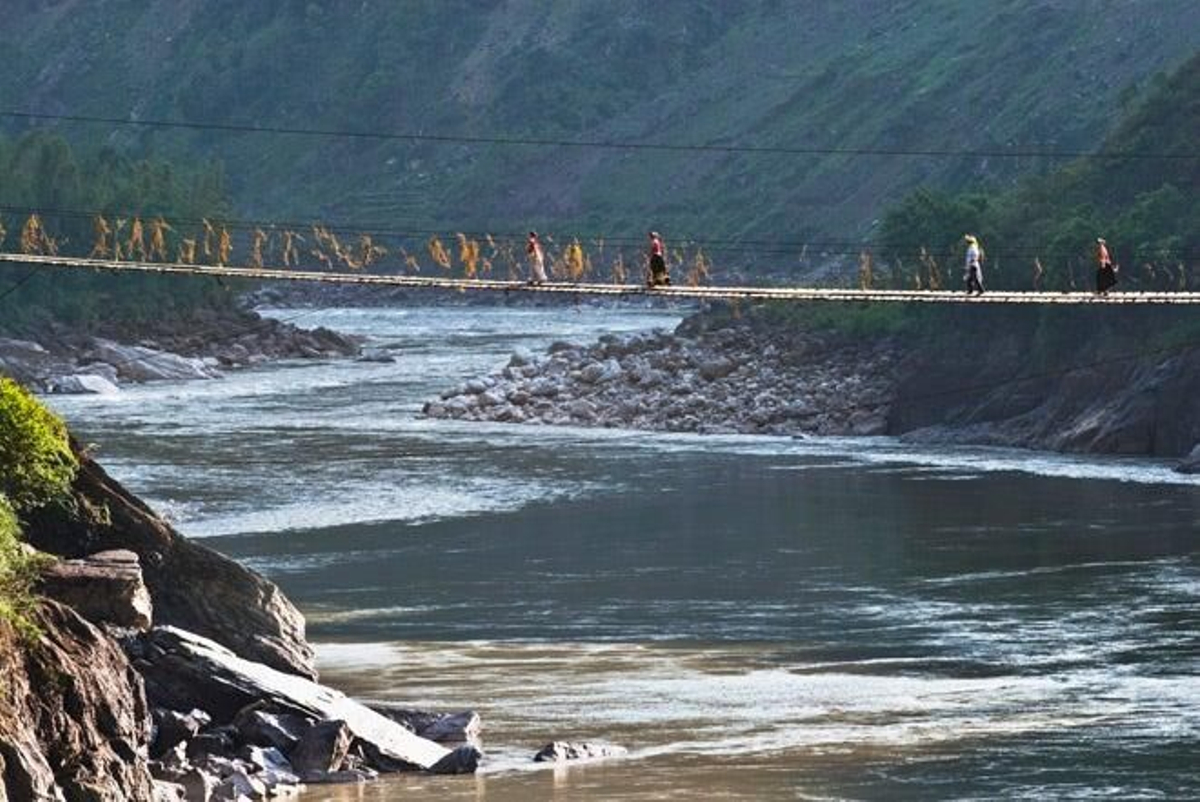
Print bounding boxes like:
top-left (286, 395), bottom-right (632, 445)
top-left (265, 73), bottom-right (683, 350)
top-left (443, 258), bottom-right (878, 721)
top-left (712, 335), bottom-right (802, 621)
top-left (130, 627), bottom-right (448, 768)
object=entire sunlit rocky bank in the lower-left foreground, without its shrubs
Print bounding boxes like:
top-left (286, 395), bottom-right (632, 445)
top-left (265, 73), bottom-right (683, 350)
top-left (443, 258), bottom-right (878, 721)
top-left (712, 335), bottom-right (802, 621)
top-left (0, 445), bottom-right (624, 802)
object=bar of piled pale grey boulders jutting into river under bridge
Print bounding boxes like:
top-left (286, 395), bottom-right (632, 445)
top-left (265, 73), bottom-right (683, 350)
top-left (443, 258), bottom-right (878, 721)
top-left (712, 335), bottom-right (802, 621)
top-left (425, 316), bottom-right (899, 435)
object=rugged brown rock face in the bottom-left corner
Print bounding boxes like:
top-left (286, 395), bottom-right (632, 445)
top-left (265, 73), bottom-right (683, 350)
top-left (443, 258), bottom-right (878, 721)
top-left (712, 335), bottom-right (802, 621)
top-left (0, 602), bottom-right (155, 802)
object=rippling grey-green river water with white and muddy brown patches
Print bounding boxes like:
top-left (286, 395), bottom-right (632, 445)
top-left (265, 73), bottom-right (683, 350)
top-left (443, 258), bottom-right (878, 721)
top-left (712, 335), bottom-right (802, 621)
top-left (52, 307), bottom-right (1200, 802)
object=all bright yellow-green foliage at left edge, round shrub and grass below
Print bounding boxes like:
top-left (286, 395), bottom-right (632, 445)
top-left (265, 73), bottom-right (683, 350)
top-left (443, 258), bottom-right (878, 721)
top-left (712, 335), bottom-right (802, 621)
top-left (0, 378), bottom-right (78, 632)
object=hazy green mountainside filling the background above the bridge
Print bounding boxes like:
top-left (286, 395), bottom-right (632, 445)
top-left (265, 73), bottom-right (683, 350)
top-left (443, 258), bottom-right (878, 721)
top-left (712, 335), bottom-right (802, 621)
top-left (0, 0), bottom-right (1200, 272)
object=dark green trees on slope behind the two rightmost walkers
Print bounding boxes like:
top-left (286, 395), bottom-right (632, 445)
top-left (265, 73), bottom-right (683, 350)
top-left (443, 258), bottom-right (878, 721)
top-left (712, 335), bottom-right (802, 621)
top-left (876, 55), bottom-right (1200, 289)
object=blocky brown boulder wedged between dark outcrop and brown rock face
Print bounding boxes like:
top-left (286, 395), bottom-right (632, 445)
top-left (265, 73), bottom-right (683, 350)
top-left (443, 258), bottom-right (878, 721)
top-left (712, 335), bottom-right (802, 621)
top-left (38, 549), bottom-right (154, 629)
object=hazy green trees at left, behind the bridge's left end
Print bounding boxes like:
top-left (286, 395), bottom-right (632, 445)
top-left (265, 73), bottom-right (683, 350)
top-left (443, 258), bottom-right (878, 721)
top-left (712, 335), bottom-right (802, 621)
top-left (0, 133), bottom-right (228, 337)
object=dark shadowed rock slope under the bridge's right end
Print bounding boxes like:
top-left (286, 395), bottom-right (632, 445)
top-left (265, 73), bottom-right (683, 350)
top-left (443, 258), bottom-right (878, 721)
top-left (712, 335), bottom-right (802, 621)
top-left (888, 310), bottom-right (1200, 457)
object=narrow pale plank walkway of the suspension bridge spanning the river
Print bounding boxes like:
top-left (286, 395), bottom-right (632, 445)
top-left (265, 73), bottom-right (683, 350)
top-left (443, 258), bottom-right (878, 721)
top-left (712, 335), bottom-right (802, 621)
top-left (0, 253), bottom-right (1200, 305)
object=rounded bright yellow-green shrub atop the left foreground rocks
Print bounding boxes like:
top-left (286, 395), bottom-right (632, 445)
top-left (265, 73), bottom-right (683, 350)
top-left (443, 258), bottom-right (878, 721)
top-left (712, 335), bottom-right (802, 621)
top-left (0, 378), bottom-right (79, 513)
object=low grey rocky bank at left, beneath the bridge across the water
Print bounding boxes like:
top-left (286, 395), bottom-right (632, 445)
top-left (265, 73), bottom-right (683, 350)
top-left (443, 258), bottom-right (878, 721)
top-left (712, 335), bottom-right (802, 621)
top-left (0, 309), bottom-right (360, 394)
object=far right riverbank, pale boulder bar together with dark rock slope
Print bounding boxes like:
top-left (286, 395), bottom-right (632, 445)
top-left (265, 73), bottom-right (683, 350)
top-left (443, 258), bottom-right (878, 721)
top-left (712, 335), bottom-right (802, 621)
top-left (424, 309), bottom-right (1200, 469)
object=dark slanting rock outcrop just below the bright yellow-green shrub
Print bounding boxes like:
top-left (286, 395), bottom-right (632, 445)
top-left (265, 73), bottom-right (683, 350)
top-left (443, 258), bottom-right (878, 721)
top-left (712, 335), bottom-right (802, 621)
top-left (26, 455), bottom-right (317, 678)
